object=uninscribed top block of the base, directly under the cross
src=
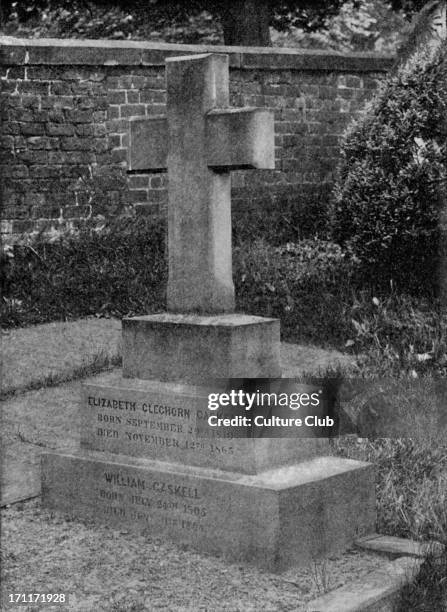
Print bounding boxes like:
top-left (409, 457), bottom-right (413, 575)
top-left (123, 313), bottom-right (280, 384)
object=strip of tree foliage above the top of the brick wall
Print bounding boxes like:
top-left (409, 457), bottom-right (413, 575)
top-left (1, 0), bottom-right (440, 45)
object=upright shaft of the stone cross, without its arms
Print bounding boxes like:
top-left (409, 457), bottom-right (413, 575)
top-left (166, 54), bottom-right (234, 313)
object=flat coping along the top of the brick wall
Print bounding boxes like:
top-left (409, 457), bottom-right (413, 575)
top-left (0, 36), bottom-right (395, 72)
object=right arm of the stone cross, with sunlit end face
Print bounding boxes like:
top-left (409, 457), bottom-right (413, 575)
top-left (206, 107), bottom-right (275, 171)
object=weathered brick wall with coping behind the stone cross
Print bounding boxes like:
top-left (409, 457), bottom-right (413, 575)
top-left (0, 38), bottom-right (392, 242)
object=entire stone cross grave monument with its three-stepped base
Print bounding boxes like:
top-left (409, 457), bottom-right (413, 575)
top-left (42, 54), bottom-right (375, 571)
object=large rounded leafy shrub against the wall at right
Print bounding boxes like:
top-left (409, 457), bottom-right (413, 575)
top-left (332, 45), bottom-right (447, 292)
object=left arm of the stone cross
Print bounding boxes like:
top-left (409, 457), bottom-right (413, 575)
top-left (128, 115), bottom-right (168, 172)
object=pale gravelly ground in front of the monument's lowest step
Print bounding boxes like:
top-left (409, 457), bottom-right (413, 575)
top-left (2, 499), bottom-right (383, 612)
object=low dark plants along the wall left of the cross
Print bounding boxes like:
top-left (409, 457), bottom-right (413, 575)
top-left (2, 217), bottom-right (166, 326)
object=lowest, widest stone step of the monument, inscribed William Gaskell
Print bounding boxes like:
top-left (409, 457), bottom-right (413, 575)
top-left (42, 451), bottom-right (375, 571)
